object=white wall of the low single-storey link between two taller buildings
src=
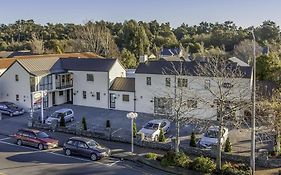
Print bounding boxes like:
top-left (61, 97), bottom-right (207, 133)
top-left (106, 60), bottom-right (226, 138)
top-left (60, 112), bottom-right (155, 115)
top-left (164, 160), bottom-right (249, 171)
top-left (109, 91), bottom-right (135, 111)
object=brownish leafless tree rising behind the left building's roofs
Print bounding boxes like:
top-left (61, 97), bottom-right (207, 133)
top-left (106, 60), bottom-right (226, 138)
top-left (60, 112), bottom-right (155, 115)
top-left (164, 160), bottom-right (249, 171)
top-left (72, 21), bottom-right (118, 57)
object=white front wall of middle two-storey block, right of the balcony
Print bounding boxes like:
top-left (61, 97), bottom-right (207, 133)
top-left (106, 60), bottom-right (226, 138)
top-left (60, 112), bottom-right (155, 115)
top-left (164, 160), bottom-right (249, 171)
top-left (71, 71), bottom-right (109, 108)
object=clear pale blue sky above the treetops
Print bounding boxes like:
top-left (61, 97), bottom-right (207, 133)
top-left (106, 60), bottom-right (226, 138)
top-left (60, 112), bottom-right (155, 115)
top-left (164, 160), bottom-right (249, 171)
top-left (0, 0), bottom-right (281, 27)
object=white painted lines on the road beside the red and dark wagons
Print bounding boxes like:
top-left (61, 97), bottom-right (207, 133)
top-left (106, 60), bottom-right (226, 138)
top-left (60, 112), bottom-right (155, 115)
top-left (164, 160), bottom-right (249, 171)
top-left (0, 140), bottom-right (114, 166)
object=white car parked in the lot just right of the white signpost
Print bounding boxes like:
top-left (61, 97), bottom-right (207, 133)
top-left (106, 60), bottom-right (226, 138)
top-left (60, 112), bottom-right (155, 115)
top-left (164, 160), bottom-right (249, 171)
top-left (138, 119), bottom-right (171, 141)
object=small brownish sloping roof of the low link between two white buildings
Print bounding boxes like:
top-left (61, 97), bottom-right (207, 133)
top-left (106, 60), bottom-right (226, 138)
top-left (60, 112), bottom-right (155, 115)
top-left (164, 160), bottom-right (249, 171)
top-left (109, 77), bottom-right (135, 92)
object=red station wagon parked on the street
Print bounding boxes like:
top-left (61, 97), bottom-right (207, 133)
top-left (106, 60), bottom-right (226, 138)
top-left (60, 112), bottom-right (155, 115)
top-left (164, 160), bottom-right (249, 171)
top-left (13, 129), bottom-right (59, 150)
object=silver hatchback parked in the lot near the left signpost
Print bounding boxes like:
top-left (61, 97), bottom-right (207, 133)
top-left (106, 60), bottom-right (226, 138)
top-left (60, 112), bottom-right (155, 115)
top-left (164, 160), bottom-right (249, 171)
top-left (46, 108), bottom-right (74, 125)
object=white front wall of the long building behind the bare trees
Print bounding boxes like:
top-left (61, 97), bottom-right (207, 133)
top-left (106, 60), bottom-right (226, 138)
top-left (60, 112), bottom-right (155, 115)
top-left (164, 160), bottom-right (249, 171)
top-left (135, 74), bottom-right (251, 119)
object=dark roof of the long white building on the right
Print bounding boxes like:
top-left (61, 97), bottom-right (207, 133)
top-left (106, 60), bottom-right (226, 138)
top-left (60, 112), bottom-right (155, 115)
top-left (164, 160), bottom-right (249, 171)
top-left (135, 61), bottom-right (252, 78)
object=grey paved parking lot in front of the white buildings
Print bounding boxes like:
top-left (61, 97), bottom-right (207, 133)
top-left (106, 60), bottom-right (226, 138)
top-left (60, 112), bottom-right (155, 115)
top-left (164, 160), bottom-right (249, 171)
top-left (0, 104), bottom-right (272, 154)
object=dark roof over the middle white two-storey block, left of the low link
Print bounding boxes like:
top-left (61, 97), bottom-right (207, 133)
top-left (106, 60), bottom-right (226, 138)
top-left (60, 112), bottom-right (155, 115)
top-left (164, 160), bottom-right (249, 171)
top-left (60, 58), bottom-right (116, 72)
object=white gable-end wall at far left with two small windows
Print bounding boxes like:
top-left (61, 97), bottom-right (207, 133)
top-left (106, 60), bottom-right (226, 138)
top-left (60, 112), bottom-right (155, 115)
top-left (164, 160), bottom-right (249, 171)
top-left (0, 62), bottom-right (31, 110)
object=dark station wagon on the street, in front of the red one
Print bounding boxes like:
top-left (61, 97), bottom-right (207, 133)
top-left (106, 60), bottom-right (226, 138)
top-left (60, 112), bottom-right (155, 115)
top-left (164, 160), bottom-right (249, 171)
top-left (63, 137), bottom-right (111, 161)
